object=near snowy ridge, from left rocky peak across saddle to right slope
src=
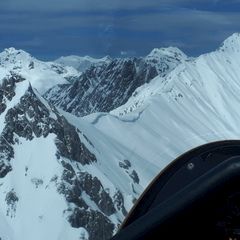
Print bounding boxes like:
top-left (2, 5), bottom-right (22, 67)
top-left (0, 34), bottom-right (240, 240)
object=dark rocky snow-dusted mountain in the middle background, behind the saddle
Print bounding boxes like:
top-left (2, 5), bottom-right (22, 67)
top-left (45, 48), bottom-right (188, 116)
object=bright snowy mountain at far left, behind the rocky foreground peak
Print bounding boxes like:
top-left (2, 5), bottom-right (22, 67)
top-left (0, 48), bottom-right (80, 94)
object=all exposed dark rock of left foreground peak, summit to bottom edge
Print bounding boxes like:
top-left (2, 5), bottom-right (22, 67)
top-left (0, 73), bottom-right (124, 240)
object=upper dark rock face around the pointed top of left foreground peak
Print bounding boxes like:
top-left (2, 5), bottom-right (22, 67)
top-left (0, 75), bottom-right (96, 175)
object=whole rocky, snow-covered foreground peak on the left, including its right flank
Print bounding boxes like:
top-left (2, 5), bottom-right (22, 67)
top-left (0, 72), bottom-right (154, 240)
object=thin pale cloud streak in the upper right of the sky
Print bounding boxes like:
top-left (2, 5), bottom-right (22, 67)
top-left (112, 9), bottom-right (240, 34)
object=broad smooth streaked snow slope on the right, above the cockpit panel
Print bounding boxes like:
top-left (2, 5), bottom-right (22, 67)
top-left (84, 34), bottom-right (240, 170)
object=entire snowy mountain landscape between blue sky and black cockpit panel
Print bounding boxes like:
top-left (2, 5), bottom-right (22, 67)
top-left (0, 33), bottom-right (240, 240)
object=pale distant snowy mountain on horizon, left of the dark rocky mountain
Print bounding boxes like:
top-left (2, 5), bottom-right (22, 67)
top-left (54, 55), bottom-right (111, 72)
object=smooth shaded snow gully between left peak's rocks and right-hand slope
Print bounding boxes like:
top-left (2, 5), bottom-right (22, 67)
top-left (62, 111), bottom-right (156, 190)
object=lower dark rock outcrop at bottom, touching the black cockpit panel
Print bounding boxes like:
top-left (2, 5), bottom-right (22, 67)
top-left (58, 162), bottom-right (116, 240)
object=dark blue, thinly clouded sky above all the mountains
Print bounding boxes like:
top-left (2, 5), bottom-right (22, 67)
top-left (0, 0), bottom-right (240, 59)
